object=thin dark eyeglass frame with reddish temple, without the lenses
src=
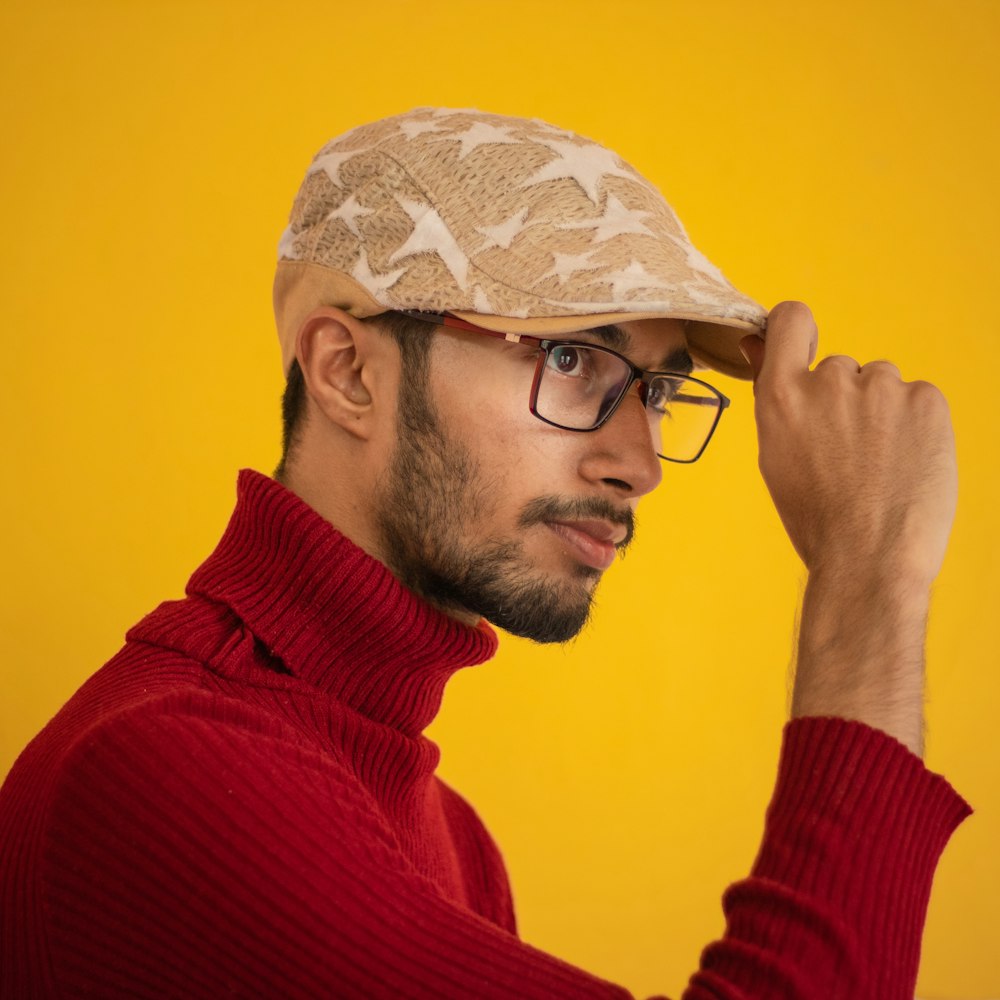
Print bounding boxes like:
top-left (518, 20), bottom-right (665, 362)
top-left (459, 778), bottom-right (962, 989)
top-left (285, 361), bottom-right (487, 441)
top-left (396, 309), bottom-right (731, 465)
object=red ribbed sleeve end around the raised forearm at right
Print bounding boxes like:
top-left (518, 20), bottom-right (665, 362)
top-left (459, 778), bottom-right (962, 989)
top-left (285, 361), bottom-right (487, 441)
top-left (684, 718), bottom-right (971, 1000)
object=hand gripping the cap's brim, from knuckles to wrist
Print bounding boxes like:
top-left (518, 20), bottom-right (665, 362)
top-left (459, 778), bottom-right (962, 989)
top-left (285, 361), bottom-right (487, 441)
top-left (743, 302), bottom-right (956, 584)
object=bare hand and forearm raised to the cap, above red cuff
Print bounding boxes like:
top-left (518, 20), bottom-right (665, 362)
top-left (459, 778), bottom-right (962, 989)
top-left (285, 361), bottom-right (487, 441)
top-left (741, 302), bottom-right (956, 753)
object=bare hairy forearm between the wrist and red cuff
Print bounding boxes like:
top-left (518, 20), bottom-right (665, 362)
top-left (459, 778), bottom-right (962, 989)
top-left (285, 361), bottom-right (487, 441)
top-left (791, 559), bottom-right (930, 756)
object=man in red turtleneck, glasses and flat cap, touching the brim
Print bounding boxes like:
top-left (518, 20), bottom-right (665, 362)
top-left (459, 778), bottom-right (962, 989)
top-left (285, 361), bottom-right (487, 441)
top-left (0, 109), bottom-right (968, 1000)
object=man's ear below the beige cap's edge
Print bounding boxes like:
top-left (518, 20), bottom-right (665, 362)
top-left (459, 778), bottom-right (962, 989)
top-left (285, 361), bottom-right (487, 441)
top-left (295, 306), bottom-right (378, 438)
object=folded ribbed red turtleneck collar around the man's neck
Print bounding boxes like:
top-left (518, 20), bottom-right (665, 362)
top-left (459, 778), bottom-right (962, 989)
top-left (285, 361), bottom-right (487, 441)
top-left (187, 469), bottom-right (497, 735)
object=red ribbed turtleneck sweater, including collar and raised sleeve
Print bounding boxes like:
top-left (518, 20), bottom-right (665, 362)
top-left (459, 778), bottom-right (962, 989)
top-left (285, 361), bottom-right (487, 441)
top-left (0, 471), bottom-right (969, 1000)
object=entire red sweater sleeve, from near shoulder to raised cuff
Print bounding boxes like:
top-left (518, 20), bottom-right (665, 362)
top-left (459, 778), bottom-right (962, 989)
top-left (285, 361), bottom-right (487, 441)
top-left (43, 712), bottom-right (967, 1000)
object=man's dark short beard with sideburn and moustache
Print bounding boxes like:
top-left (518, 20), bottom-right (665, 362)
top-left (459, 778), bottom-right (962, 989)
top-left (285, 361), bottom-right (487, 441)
top-left (375, 372), bottom-right (635, 643)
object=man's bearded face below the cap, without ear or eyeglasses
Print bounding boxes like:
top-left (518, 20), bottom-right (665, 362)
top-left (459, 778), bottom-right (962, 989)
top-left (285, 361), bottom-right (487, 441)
top-left (375, 321), bottom-right (684, 642)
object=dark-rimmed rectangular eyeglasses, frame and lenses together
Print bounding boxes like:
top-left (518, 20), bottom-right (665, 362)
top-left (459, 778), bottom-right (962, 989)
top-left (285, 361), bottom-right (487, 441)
top-left (400, 310), bottom-right (729, 463)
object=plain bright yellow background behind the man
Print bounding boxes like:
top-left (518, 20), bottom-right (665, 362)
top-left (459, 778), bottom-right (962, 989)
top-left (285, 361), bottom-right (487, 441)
top-left (0, 0), bottom-right (1000, 998)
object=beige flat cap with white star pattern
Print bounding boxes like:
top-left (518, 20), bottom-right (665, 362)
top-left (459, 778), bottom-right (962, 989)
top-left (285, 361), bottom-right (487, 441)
top-left (274, 108), bottom-right (766, 378)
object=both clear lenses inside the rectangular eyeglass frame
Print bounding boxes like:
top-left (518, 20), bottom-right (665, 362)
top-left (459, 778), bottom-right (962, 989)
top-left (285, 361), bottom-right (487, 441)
top-left (535, 344), bottom-right (720, 462)
